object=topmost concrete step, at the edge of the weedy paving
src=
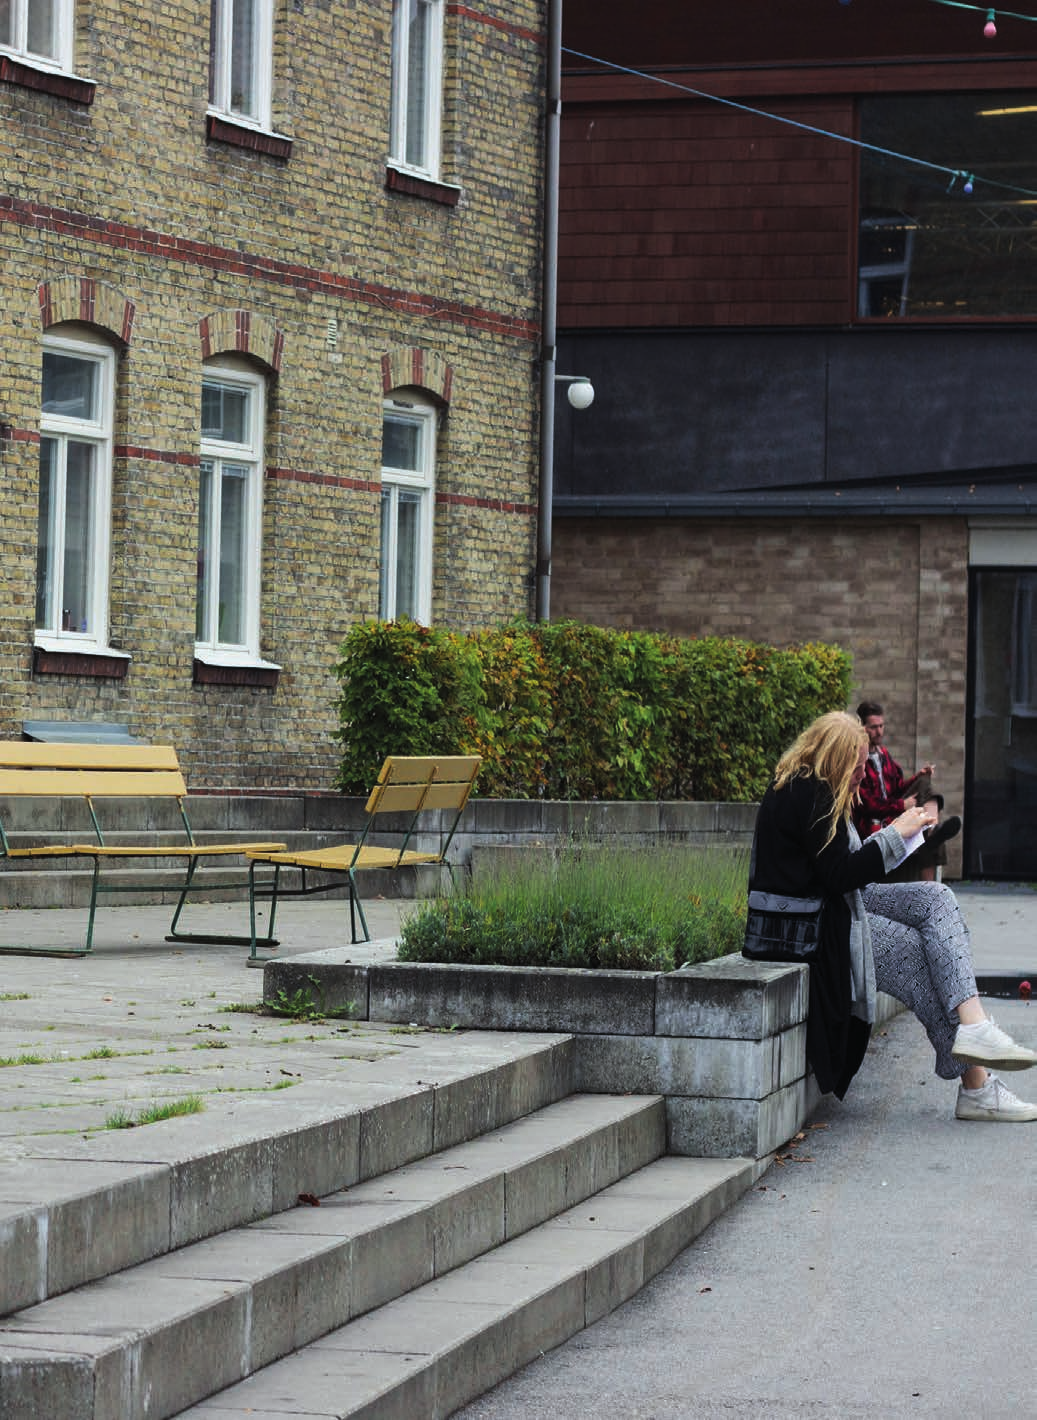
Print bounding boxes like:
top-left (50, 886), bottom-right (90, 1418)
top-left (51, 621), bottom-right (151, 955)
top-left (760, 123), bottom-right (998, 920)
top-left (0, 1037), bottom-right (575, 1312)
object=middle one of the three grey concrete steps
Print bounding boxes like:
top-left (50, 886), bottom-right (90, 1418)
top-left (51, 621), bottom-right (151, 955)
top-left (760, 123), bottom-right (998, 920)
top-left (0, 1095), bottom-right (661, 1420)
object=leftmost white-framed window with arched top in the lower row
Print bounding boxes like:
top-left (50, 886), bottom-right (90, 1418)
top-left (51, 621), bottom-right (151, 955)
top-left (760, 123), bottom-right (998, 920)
top-left (36, 335), bottom-right (115, 650)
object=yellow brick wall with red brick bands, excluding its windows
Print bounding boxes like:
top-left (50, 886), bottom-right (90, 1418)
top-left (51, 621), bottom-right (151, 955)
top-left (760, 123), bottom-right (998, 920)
top-left (0, 0), bottom-right (544, 787)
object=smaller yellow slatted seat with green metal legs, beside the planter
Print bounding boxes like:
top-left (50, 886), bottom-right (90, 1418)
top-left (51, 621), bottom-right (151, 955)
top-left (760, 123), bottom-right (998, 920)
top-left (246, 754), bottom-right (483, 959)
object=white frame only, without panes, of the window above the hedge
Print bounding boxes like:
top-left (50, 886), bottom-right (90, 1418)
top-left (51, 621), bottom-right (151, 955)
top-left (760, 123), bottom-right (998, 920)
top-left (378, 392), bottom-right (438, 626)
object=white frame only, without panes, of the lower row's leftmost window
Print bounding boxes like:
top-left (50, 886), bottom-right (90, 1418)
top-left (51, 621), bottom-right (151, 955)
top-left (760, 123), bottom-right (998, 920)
top-left (34, 335), bottom-right (115, 653)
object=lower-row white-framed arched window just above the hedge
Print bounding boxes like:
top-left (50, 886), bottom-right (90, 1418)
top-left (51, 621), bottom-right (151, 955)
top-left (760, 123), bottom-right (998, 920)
top-left (378, 396), bottom-right (436, 625)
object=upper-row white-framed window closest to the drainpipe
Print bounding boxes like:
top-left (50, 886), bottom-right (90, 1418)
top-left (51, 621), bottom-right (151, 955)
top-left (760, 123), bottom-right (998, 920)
top-left (389, 0), bottom-right (443, 180)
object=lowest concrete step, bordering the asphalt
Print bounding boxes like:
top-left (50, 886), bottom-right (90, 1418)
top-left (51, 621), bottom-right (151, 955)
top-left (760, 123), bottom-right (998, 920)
top-left (169, 1157), bottom-right (759, 1420)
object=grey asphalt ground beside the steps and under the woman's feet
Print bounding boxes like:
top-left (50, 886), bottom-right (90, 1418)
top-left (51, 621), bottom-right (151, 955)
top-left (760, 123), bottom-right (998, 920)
top-left (456, 885), bottom-right (1037, 1420)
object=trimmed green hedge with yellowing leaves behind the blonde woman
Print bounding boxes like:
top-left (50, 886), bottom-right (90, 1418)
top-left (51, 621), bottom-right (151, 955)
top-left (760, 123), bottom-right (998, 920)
top-left (334, 621), bottom-right (851, 802)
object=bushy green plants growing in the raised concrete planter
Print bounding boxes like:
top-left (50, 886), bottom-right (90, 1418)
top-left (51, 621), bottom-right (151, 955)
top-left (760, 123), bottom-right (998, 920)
top-left (398, 843), bottom-right (749, 971)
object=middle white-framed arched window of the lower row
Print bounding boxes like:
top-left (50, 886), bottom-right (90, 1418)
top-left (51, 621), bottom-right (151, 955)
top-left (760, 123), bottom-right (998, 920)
top-left (195, 364), bottom-right (266, 663)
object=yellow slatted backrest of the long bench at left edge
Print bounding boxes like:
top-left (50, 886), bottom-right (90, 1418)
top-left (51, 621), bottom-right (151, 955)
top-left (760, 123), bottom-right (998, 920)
top-left (0, 740), bottom-right (188, 798)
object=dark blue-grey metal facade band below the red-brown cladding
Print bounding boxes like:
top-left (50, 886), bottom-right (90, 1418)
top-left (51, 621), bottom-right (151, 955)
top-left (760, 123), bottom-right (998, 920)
top-left (555, 327), bottom-right (1037, 506)
